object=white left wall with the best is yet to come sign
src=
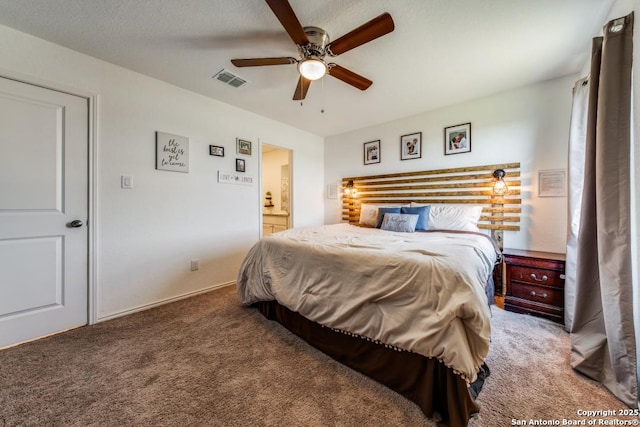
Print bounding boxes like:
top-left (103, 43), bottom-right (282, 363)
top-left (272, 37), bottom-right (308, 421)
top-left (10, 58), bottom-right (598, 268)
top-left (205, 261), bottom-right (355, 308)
top-left (0, 26), bottom-right (324, 318)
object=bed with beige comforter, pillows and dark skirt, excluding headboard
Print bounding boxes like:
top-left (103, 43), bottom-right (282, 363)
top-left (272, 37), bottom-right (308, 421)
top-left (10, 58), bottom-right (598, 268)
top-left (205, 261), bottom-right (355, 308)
top-left (237, 164), bottom-right (520, 426)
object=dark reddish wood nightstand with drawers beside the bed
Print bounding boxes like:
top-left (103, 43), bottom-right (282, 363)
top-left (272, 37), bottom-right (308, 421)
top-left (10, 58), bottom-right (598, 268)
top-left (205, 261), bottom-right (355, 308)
top-left (503, 249), bottom-right (565, 323)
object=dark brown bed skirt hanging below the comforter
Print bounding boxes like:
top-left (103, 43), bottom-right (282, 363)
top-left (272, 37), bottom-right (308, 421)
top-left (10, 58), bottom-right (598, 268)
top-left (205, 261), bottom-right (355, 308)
top-left (253, 301), bottom-right (489, 427)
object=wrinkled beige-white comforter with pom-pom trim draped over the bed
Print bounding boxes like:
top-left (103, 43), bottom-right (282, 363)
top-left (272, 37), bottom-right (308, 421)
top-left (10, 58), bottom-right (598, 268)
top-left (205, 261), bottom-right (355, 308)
top-left (238, 224), bottom-right (497, 382)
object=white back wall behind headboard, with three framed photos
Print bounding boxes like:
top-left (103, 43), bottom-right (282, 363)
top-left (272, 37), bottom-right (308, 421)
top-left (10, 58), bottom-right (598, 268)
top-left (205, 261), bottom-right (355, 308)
top-left (325, 75), bottom-right (579, 253)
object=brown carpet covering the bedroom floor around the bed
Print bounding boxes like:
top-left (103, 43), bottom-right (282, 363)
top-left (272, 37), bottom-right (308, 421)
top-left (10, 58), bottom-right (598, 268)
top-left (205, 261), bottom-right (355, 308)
top-left (0, 287), bottom-right (623, 427)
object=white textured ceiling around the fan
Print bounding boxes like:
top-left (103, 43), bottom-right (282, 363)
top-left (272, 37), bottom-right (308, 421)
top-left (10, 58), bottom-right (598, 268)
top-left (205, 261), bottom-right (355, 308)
top-left (0, 0), bottom-right (613, 136)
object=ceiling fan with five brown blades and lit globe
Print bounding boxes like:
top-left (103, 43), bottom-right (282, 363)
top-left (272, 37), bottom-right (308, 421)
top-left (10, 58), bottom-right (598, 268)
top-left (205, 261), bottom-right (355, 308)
top-left (231, 0), bottom-right (394, 101)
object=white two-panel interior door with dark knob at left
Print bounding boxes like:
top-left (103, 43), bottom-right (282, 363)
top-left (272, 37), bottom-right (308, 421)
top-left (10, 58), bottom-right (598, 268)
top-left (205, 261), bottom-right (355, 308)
top-left (0, 78), bottom-right (89, 348)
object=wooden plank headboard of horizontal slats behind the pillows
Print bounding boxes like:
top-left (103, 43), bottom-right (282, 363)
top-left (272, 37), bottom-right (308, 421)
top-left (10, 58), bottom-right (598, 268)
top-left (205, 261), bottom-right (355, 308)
top-left (342, 163), bottom-right (522, 231)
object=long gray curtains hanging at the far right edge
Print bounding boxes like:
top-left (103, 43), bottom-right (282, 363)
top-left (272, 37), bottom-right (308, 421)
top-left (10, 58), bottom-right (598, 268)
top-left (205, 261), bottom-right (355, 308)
top-left (565, 13), bottom-right (638, 407)
